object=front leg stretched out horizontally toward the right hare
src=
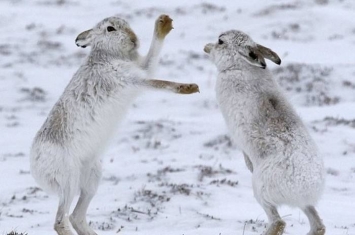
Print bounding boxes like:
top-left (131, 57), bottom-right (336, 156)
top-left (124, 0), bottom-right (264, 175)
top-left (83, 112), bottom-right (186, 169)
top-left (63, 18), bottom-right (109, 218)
top-left (142, 79), bottom-right (200, 94)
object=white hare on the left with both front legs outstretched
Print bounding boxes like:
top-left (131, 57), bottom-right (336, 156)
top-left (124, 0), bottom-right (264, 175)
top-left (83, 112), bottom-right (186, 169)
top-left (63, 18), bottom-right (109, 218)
top-left (30, 15), bottom-right (198, 235)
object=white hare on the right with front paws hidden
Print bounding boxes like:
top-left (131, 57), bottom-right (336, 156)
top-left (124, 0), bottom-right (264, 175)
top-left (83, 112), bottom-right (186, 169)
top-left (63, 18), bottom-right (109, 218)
top-left (204, 30), bottom-right (325, 235)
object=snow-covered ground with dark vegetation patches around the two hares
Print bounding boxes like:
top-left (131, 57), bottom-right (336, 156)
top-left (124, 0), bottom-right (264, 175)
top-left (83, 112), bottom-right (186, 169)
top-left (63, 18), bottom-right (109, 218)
top-left (0, 0), bottom-right (355, 235)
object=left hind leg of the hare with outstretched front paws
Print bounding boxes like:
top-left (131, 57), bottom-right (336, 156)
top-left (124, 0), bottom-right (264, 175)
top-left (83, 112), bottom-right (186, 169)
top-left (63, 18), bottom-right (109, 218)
top-left (54, 186), bottom-right (75, 235)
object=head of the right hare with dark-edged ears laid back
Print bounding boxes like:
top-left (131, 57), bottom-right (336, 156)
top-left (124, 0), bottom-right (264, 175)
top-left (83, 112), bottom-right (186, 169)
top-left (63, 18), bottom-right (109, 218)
top-left (204, 30), bottom-right (281, 70)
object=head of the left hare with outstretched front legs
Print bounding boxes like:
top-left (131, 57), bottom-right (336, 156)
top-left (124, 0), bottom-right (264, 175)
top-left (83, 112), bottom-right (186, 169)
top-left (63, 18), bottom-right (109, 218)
top-left (75, 17), bottom-right (139, 57)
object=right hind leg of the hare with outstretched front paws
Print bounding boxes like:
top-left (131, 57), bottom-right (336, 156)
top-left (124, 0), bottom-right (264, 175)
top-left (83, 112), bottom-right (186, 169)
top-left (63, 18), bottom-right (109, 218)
top-left (70, 161), bottom-right (102, 235)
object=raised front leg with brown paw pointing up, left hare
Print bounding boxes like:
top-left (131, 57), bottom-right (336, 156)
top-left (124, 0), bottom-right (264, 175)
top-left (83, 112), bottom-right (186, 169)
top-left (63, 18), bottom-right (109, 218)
top-left (140, 15), bottom-right (173, 76)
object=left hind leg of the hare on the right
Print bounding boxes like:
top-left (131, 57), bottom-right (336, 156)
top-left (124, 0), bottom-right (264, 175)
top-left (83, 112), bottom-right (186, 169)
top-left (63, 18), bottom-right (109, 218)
top-left (262, 205), bottom-right (286, 235)
